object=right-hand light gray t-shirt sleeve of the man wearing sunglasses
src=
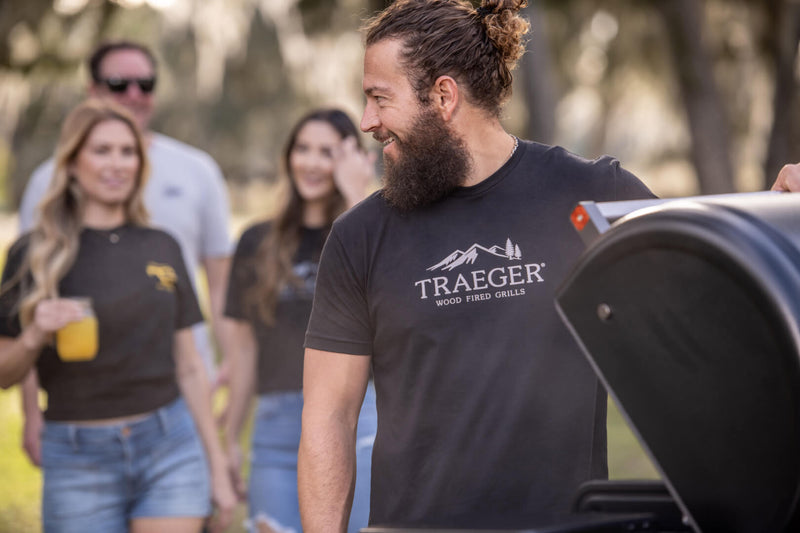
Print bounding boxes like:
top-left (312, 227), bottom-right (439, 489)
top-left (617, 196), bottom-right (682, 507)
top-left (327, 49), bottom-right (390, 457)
top-left (200, 156), bottom-right (231, 257)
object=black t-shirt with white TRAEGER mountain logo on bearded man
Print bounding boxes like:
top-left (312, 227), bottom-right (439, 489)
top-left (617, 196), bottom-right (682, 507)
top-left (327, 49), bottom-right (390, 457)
top-left (306, 142), bottom-right (652, 528)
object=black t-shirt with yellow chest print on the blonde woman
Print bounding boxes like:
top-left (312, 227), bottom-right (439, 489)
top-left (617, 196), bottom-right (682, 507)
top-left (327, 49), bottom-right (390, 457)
top-left (0, 225), bottom-right (203, 421)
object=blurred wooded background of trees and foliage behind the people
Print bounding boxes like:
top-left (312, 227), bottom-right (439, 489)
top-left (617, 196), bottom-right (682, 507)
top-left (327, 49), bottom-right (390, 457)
top-left (0, 0), bottom-right (800, 211)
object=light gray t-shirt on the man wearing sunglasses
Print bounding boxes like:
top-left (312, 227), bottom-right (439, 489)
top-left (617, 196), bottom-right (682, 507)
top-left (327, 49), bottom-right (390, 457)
top-left (19, 133), bottom-right (232, 375)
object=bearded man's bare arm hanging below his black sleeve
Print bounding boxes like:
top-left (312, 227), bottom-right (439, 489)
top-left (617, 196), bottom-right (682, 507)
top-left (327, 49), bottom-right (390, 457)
top-left (297, 348), bottom-right (371, 533)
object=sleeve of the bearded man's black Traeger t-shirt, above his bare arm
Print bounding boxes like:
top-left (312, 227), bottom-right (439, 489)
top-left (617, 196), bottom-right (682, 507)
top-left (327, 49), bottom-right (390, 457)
top-left (305, 224), bottom-right (373, 355)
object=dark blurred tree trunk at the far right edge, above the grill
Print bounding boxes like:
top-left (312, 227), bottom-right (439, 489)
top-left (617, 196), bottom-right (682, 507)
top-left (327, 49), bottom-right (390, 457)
top-left (764, 0), bottom-right (800, 189)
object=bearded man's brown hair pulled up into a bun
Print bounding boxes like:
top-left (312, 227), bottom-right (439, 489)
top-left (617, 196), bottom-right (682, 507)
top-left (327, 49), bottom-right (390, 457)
top-left (362, 0), bottom-right (530, 117)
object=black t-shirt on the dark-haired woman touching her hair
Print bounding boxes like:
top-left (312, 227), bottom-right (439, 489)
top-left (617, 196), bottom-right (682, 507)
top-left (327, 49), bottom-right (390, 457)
top-left (225, 222), bottom-right (328, 394)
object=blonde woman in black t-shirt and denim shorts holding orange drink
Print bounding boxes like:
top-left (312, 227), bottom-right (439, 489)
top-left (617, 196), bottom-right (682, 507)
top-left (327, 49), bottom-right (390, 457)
top-left (0, 100), bottom-right (235, 533)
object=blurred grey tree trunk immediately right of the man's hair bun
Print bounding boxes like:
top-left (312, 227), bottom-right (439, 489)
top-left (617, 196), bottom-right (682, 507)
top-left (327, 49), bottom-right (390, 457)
top-left (520, 1), bottom-right (556, 144)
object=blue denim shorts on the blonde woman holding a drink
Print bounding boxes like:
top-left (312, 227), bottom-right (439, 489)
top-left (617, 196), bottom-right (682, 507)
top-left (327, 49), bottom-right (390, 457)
top-left (42, 398), bottom-right (211, 533)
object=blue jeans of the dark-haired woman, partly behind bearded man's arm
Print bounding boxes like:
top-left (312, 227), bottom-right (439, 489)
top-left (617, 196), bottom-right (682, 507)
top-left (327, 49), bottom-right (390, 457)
top-left (248, 382), bottom-right (378, 533)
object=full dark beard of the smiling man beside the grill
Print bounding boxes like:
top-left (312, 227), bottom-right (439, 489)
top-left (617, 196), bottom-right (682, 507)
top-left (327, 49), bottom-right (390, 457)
top-left (382, 109), bottom-right (472, 211)
